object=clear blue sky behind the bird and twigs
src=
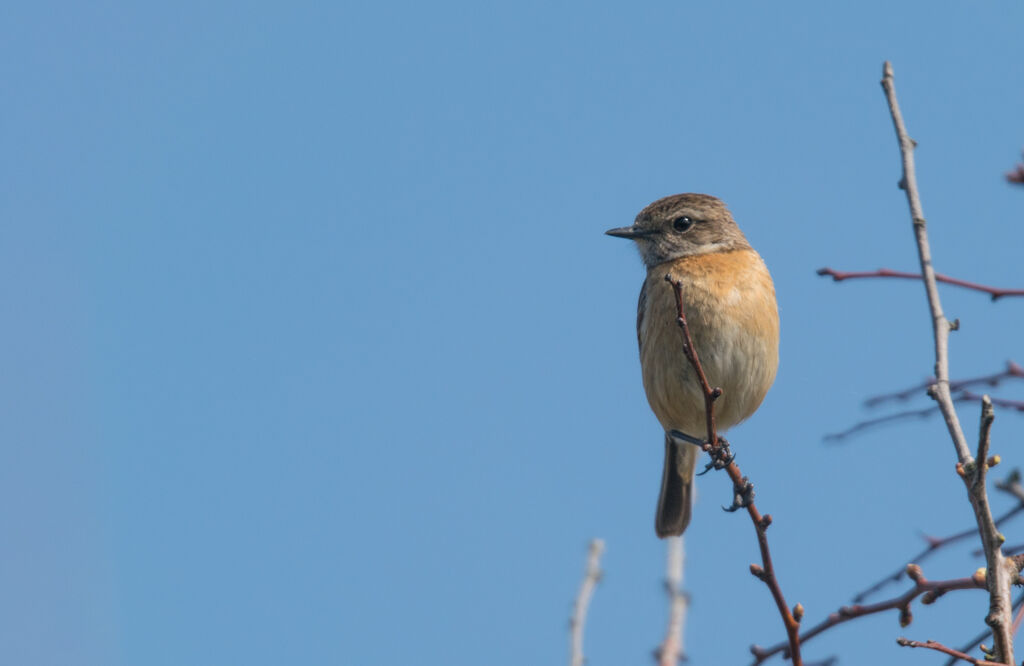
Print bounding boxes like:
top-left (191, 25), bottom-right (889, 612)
top-left (6, 1), bottom-right (1024, 666)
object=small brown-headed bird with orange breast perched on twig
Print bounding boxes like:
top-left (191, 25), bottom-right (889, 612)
top-left (605, 193), bottom-right (779, 538)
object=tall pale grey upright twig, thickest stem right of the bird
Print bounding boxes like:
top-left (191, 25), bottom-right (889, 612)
top-left (882, 61), bottom-right (1016, 664)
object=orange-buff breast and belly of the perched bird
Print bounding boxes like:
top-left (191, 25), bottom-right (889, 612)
top-left (637, 250), bottom-right (778, 438)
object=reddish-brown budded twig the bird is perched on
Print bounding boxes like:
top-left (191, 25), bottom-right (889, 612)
top-left (665, 275), bottom-right (804, 666)
